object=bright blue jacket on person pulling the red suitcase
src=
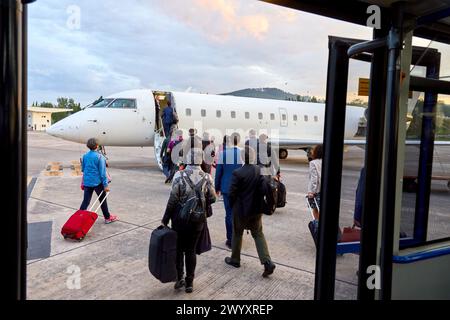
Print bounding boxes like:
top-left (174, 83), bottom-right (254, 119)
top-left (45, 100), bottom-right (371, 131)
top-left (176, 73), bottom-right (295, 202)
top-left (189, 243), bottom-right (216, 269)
top-left (81, 151), bottom-right (108, 188)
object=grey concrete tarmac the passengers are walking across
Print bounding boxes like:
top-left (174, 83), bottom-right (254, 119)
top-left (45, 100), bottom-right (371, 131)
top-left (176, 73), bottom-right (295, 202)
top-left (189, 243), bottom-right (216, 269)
top-left (27, 132), bottom-right (450, 300)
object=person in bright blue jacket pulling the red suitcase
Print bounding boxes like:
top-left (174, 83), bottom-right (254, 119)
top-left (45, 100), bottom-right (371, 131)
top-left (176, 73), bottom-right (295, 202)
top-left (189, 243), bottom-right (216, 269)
top-left (80, 138), bottom-right (119, 224)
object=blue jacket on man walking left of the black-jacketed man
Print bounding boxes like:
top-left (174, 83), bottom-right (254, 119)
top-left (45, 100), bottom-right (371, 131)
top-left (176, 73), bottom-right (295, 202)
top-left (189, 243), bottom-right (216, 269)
top-left (214, 147), bottom-right (242, 194)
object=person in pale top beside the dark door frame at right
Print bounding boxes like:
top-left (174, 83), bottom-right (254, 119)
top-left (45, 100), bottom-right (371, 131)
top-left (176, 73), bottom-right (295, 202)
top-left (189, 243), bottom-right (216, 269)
top-left (308, 144), bottom-right (323, 225)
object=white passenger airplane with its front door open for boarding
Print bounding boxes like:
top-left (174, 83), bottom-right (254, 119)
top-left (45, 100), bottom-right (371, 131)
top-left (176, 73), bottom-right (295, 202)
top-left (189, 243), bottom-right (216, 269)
top-left (47, 89), bottom-right (366, 169)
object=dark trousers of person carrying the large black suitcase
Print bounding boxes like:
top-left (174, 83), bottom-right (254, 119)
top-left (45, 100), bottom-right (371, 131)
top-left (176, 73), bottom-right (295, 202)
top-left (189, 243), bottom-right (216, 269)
top-left (176, 226), bottom-right (203, 285)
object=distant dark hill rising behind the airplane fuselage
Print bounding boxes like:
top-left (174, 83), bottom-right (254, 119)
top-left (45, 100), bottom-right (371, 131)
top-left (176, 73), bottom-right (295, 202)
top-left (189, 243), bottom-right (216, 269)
top-left (222, 88), bottom-right (317, 102)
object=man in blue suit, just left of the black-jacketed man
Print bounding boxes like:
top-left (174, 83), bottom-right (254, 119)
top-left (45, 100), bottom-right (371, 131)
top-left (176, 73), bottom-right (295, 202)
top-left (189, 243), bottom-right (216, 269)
top-left (215, 132), bottom-right (242, 249)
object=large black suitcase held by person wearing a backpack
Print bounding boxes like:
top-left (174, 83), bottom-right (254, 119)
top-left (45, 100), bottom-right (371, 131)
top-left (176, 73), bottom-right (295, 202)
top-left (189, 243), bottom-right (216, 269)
top-left (148, 226), bottom-right (177, 283)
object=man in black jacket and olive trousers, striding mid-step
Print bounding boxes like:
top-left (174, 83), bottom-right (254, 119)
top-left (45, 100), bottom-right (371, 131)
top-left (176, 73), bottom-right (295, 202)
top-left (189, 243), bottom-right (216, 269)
top-left (225, 146), bottom-right (275, 277)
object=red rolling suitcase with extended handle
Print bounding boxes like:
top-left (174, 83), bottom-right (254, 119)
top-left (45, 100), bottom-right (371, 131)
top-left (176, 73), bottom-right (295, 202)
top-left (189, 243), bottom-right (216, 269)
top-left (61, 192), bottom-right (109, 241)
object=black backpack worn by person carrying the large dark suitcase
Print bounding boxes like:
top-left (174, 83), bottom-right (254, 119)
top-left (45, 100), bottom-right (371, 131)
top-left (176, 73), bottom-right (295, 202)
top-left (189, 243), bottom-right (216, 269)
top-left (178, 171), bottom-right (207, 225)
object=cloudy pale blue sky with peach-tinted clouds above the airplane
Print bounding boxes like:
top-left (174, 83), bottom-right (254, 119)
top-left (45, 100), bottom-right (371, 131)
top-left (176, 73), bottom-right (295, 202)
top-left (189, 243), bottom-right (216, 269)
top-left (29, 0), bottom-right (450, 105)
